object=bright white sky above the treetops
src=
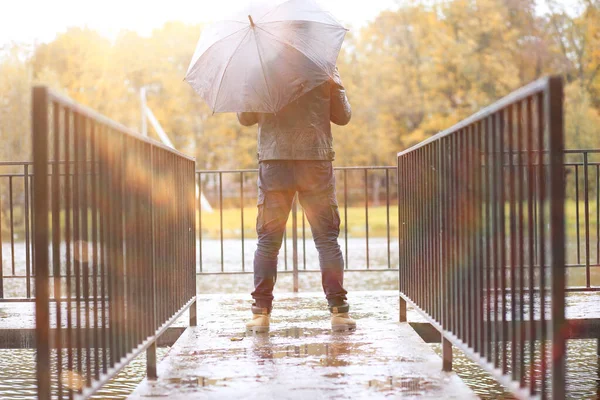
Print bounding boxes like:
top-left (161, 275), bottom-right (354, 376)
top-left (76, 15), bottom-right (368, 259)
top-left (0, 0), bottom-right (404, 45)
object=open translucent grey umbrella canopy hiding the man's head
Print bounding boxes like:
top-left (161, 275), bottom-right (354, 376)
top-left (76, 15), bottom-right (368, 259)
top-left (185, 0), bottom-right (347, 113)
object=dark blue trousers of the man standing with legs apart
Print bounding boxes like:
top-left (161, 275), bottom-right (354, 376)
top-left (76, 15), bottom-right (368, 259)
top-left (252, 160), bottom-right (349, 312)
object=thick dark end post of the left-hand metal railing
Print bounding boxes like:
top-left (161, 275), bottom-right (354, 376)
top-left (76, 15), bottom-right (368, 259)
top-left (32, 86), bottom-right (52, 400)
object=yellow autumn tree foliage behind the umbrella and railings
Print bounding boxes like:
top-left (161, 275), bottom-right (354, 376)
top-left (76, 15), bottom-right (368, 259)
top-left (0, 0), bottom-right (600, 169)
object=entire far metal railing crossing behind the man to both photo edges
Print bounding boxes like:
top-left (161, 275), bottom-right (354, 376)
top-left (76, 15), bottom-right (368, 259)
top-left (0, 149), bottom-right (600, 301)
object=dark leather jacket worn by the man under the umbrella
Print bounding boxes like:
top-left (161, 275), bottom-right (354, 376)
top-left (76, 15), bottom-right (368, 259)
top-left (238, 74), bottom-right (351, 162)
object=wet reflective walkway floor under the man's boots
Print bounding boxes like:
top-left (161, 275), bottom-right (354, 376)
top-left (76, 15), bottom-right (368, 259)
top-left (129, 291), bottom-right (476, 399)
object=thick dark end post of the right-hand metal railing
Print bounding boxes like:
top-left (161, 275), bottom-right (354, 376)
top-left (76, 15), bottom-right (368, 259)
top-left (544, 77), bottom-right (566, 399)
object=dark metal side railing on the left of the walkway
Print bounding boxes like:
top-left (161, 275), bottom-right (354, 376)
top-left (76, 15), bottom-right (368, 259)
top-left (32, 87), bottom-right (196, 399)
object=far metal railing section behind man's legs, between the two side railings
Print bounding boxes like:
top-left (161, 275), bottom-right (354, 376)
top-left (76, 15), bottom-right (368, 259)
top-left (197, 167), bottom-right (397, 274)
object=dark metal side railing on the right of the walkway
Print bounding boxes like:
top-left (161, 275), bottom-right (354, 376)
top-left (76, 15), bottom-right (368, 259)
top-left (398, 78), bottom-right (568, 399)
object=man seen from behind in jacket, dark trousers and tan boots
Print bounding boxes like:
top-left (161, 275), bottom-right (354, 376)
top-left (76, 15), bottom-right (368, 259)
top-left (238, 68), bottom-right (356, 332)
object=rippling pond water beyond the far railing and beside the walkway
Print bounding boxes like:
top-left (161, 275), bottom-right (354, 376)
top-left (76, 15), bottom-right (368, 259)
top-left (0, 238), bottom-right (600, 399)
